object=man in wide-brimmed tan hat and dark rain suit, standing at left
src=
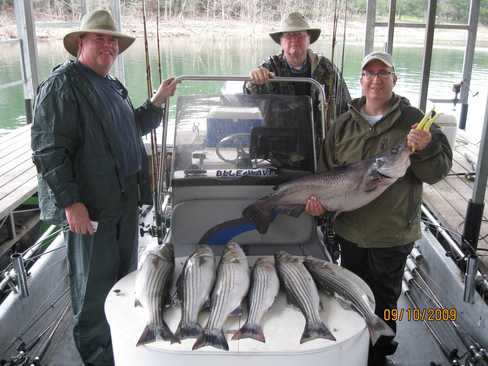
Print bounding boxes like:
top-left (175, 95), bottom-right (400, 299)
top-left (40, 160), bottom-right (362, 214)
top-left (32, 10), bottom-right (176, 366)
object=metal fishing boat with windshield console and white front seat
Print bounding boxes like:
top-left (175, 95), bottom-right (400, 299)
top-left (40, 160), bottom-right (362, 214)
top-left (0, 0), bottom-right (488, 366)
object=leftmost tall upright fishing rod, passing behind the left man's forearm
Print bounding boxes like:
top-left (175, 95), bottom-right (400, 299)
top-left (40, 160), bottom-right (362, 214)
top-left (142, 0), bottom-right (164, 245)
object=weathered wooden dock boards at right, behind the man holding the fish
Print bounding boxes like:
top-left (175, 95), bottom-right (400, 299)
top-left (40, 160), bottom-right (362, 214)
top-left (423, 133), bottom-right (488, 273)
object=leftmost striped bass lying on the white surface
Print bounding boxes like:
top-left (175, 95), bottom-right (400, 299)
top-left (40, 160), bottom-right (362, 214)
top-left (136, 244), bottom-right (179, 346)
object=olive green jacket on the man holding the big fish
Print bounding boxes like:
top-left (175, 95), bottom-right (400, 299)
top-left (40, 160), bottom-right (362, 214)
top-left (321, 95), bottom-right (452, 247)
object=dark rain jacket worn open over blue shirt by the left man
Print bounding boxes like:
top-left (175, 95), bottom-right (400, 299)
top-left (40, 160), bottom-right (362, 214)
top-left (31, 61), bottom-right (162, 224)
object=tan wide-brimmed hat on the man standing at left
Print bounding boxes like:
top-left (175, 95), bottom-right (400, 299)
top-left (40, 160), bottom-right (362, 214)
top-left (63, 9), bottom-right (135, 57)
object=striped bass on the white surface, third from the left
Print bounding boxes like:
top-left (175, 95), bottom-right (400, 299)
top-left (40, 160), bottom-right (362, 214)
top-left (193, 243), bottom-right (249, 351)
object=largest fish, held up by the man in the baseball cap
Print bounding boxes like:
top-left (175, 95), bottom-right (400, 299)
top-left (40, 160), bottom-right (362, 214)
top-left (242, 146), bottom-right (410, 234)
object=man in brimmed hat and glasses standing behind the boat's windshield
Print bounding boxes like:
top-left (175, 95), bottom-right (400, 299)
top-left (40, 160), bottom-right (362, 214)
top-left (246, 13), bottom-right (351, 129)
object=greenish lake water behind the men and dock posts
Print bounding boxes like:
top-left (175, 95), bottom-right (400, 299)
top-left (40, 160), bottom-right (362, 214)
top-left (0, 37), bottom-right (488, 139)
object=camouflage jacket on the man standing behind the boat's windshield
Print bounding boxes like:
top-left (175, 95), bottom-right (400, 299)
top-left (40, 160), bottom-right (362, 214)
top-left (245, 50), bottom-right (351, 135)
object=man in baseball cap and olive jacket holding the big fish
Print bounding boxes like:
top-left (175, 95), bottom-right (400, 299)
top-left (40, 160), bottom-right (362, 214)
top-left (305, 52), bottom-right (452, 366)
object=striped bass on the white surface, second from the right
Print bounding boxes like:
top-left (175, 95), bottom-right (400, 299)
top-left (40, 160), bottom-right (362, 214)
top-left (275, 251), bottom-right (336, 343)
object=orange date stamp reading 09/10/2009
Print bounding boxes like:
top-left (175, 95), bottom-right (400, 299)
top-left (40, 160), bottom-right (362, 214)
top-left (383, 307), bottom-right (458, 321)
